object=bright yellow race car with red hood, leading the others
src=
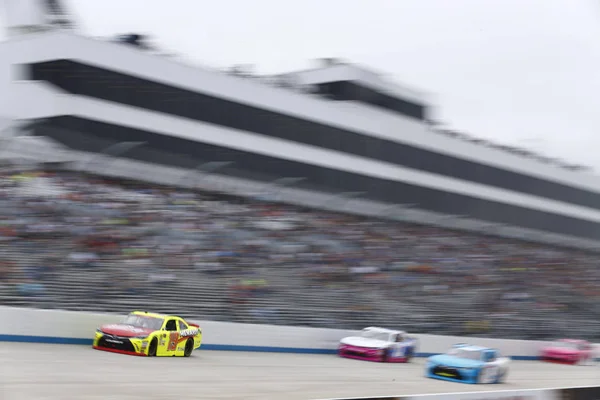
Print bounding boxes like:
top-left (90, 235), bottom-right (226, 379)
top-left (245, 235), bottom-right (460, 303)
top-left (92, 311), bottom-right (202, 357)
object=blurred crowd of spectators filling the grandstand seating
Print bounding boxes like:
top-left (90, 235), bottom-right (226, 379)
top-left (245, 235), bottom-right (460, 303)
top-left (0, 169), bottom-right (600, 339)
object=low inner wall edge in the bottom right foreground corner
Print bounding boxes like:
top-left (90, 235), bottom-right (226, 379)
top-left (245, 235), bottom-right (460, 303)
top-left (312, 386), bottom-right (600, 400)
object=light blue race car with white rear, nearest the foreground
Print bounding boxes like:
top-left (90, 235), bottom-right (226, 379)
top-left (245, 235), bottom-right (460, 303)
top-left (425, 344), bottom-right (510, 383)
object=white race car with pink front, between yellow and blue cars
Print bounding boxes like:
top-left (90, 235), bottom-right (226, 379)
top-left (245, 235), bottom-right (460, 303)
top-left (338, 327), bottom-right (417, 362)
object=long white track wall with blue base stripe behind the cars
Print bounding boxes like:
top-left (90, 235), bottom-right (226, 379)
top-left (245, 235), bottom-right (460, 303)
top-left (0, 307), bottom-right (600, 360)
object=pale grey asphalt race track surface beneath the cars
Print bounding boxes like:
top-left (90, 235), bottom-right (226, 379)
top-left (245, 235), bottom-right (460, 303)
top-left (0, 343), bottom-right (600, 400)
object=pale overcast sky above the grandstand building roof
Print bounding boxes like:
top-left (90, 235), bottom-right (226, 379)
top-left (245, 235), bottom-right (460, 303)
top-left (11, 0), bottom-right (600, 169)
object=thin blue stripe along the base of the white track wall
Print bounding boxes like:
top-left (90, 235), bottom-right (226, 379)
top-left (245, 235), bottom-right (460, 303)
top-left (0, 335), bottom-right (548, 360)
